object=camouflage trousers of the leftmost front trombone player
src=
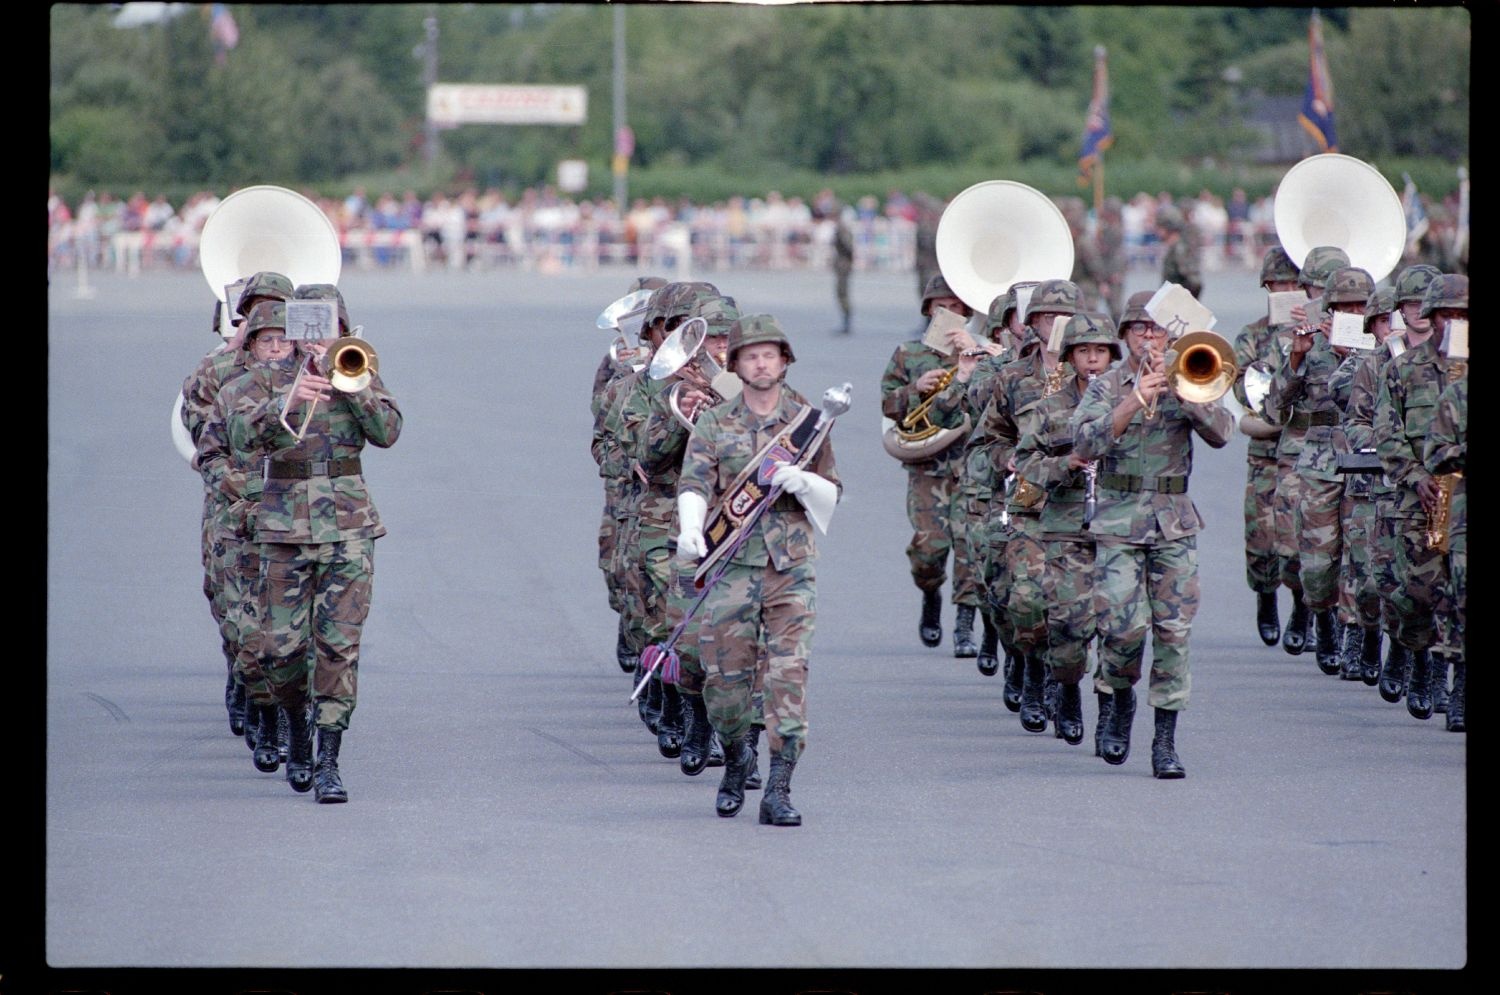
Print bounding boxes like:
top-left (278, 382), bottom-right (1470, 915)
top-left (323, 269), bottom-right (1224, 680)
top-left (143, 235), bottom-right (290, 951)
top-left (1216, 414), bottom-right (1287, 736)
top-left (255, 539), bottom-right (375, 729)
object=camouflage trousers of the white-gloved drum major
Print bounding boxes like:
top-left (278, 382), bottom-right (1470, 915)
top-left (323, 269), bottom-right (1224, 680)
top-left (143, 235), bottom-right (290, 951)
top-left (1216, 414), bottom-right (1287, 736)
top-left (698, 557), bottom-right (818, 761)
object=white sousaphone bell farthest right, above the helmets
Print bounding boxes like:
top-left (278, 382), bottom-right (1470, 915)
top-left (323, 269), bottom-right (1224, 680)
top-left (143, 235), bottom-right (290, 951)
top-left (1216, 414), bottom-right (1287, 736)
top-left (1274, 152), bottom-right (1407, 282)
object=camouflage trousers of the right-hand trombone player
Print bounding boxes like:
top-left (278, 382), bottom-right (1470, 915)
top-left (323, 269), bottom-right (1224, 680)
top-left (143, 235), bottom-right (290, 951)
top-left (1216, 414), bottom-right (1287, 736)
top-left (1094, 536), bottom-right (1199, 711)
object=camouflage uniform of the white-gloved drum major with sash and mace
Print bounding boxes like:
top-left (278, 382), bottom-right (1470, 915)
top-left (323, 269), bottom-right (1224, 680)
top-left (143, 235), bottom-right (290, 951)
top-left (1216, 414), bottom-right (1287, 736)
top-left (680, 387), bottom-right (843, 762)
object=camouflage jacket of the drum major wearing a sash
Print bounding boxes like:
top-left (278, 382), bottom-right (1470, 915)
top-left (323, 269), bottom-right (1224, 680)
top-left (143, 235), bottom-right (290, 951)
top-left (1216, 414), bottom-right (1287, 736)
top-left (680, 384), bottom-right (843, 572)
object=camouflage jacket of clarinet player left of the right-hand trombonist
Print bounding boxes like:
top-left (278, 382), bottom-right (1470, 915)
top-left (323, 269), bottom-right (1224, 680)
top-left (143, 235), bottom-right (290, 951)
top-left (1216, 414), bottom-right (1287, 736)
top-left (1016, 368), bottom-right (1091, 540)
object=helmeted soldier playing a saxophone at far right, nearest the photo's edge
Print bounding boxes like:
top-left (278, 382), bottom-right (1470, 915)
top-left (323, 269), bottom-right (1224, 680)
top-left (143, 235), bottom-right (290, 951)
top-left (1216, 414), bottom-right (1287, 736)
top-left (1376, 273), bottom-right (1469, 719)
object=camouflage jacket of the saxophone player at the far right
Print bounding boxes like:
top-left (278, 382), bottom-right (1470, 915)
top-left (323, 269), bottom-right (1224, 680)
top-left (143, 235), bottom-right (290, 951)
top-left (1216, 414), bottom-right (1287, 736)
top-left (1373, 336), bottom-right (1448, 518)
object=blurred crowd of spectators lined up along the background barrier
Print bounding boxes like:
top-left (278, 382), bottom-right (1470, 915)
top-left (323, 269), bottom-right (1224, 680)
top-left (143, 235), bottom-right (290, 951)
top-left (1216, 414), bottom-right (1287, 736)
top-left (47, 186), bottom-right (1454, 276)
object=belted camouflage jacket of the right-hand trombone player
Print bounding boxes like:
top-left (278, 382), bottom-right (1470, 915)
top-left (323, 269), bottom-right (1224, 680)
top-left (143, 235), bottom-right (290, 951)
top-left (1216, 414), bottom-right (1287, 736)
top-left (1073, 362), bottom-right (1235, 546)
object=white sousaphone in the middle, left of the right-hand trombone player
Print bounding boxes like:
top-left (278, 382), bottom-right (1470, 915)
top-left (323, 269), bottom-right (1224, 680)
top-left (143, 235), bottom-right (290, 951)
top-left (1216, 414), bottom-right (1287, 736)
top-left (882, 180), bottom-right (1073, 462)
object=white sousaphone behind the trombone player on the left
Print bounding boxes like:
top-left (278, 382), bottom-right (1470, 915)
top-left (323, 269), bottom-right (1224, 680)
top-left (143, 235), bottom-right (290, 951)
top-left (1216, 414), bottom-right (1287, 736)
top-left (171, 185), bottom-right (344, 461)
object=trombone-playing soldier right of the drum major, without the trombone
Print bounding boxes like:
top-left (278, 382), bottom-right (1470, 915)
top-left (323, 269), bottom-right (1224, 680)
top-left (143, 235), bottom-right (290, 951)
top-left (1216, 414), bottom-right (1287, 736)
top-left (1073, 306), bottom-right (1235, 779)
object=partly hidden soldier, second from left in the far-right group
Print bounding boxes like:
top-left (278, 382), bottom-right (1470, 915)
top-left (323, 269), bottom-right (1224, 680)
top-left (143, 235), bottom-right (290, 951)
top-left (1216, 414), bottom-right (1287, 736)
top-left (1259, 246), bottom-right (1349, 656)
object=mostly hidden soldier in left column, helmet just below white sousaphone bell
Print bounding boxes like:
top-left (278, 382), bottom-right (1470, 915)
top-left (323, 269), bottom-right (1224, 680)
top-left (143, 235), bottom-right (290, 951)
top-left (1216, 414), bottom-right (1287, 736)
top-left (183, 270), bottom-right (294, 735)
